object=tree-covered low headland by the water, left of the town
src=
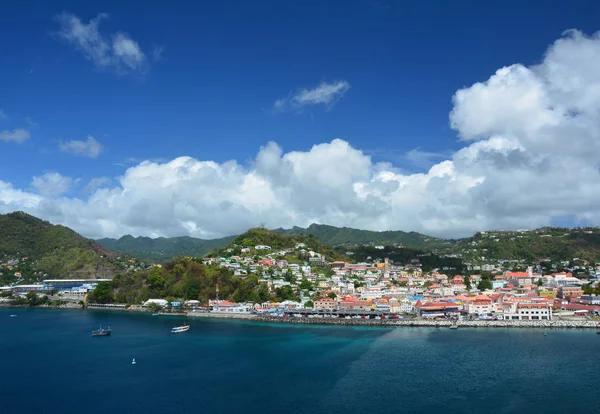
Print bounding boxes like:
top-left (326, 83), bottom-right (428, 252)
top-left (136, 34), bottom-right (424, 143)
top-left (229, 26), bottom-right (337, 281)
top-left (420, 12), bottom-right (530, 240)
top-left (88, 257), bottom-right (286, 304)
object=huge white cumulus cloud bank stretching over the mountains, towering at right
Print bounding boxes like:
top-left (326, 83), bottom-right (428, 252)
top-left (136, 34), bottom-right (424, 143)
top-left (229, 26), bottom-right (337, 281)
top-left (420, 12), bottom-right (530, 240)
top-left (0, 31), bottom-right (600, 237)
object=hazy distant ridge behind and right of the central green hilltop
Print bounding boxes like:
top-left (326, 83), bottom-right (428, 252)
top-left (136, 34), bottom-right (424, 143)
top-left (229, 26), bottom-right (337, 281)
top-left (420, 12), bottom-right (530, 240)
top-left (275, 224), bottom-right (454, 250)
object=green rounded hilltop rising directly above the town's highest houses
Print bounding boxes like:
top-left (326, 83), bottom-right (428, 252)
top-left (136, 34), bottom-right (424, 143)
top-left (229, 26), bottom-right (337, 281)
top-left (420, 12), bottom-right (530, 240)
top-left (212, 228), bottom-right (347, 260)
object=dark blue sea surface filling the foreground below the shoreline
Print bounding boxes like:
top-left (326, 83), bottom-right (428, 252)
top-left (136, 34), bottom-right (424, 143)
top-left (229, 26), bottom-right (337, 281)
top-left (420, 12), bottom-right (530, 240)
top-left (0, 308), bottom-right (600, 414)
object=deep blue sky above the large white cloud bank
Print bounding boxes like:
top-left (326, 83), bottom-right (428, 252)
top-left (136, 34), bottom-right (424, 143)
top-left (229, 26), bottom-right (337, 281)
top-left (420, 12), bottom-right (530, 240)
top-left (0, 0), bottom-right (600, 235)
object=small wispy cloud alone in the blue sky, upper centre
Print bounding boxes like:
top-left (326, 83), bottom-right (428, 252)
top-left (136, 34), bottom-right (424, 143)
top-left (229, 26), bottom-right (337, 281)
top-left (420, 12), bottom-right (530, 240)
top-left (273, 81), bottom-right (350, 112)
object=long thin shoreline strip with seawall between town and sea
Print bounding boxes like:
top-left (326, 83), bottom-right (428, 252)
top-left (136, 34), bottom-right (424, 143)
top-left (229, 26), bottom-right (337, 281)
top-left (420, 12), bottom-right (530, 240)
top-left (0, 303), bottom-right (600, 332)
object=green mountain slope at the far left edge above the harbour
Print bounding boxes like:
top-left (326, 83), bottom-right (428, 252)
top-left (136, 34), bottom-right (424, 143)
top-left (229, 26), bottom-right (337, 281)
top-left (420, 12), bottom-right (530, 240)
top-left (0, 212), bottom-right (118, 279)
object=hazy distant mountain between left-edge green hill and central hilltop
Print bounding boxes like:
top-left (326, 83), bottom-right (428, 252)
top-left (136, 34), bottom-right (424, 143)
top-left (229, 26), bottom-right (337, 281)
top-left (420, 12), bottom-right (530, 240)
top-left (96, 235), bottom-right (235, 263)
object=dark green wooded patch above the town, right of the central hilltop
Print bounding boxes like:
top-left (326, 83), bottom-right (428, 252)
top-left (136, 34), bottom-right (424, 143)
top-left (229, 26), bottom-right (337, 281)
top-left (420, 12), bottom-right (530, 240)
top-left (340, 246), bottom-right (465, 275)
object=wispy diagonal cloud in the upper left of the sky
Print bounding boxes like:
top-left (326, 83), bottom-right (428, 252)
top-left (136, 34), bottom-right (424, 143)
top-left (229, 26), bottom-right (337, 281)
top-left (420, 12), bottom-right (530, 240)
top-left (56, 13), bottom-right (148, 74)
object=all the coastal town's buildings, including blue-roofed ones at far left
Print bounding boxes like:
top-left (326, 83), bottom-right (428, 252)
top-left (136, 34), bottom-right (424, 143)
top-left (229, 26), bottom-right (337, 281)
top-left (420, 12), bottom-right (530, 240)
top-left (0, 236), bottom-right (600, 321)
